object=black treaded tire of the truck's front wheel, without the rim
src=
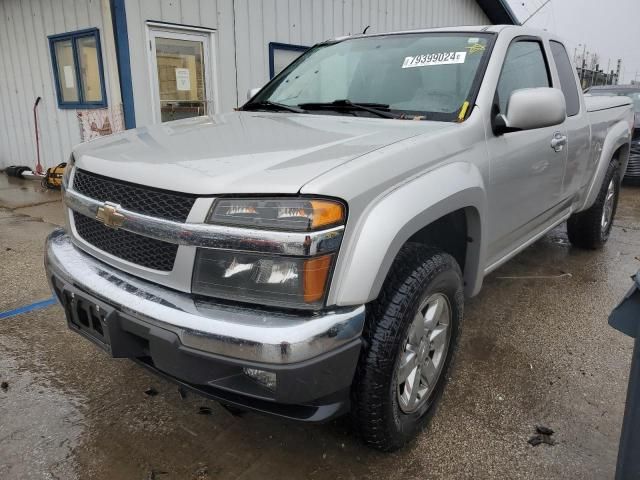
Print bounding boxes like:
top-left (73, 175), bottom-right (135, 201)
top-left (351, 244), bottom-right (464, 451)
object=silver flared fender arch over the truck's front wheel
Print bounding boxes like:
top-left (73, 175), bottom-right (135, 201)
top-left (328, 162), bottom-right (487, 305)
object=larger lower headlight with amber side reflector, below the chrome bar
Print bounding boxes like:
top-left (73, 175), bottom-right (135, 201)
top-left (192, 249), bottom-right (333, 309)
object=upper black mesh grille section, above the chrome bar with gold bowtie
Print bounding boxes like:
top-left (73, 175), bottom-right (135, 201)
top-left (73, 169), bottom-right (196, 222)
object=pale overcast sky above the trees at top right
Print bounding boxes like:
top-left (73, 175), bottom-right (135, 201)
top-left (507, 0), bottom-right (640, 83)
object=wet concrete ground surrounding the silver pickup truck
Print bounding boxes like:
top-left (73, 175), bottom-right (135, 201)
top-left (0, 175), bottom-right (640, 480)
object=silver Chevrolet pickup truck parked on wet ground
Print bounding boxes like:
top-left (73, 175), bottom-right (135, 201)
top-left (45, 26), bottom-right (634, 451)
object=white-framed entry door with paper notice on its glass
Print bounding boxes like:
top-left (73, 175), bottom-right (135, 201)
top-left (149, 27), bottom-right (214, 122)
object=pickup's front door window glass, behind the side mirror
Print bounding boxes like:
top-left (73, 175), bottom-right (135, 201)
top-left (496, 40), bottom-right (551, 114)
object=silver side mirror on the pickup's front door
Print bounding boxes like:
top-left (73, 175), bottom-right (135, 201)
top-left (493, 88), bottom-right (567, 135)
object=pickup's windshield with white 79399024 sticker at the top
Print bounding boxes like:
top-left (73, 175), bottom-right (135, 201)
top-left (245, 33), bottom-right (493, 121)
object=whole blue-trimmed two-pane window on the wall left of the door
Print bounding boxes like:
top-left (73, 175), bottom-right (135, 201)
top-left (49, 28), bottom-right (107, 108)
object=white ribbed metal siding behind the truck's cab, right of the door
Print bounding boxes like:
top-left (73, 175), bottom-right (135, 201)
top-left (234, 0), bottom-right (491, 99)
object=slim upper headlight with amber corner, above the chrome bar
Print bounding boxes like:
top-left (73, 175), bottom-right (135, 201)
top-left (209, 198), bottom-right (345, 232)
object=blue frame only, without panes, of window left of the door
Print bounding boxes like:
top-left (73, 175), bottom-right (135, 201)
top-left (47, 28), bottom-right (108, 110)
